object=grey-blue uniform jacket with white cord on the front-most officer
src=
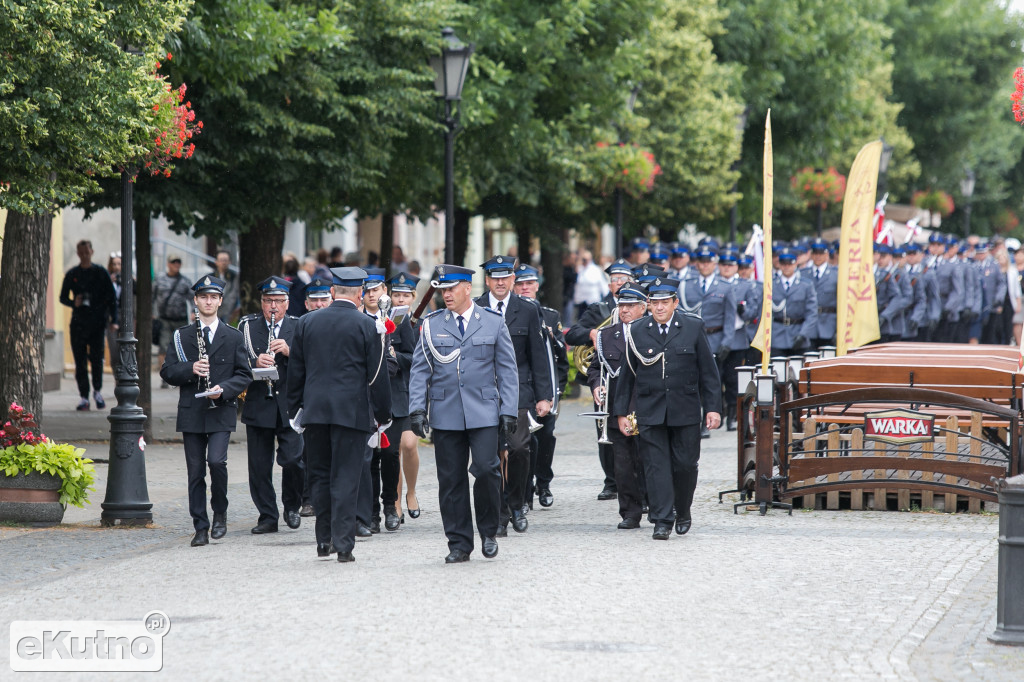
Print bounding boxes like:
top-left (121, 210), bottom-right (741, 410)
top-left (409, 304), bottom-right (519, 431)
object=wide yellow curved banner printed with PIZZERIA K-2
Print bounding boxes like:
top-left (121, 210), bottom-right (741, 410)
top-left (836, 140), bottom-right (882, 356)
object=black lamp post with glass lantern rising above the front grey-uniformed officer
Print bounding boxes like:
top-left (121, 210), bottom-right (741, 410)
top-left (430, 28), bottom-right (473, 264)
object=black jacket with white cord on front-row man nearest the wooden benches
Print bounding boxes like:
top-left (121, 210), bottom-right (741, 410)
top-left (609, 314), bottom-right (722, 426)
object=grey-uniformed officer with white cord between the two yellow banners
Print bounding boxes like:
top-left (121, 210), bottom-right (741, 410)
top-left (771, 247), bottom-right (818, 355)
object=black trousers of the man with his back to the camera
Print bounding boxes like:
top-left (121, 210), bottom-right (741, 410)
top-left (303, 424), bottom-right (370, 552)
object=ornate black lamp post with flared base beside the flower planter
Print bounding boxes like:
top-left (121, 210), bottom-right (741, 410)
top-left (99, 170), bottom-right (153, 525)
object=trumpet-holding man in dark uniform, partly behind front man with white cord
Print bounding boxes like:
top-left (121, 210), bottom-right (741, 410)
top-left (587, 286), bottom-right (647, 529)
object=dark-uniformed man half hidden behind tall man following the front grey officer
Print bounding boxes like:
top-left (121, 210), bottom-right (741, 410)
top-left (515, 265), bottom-right (569, 509)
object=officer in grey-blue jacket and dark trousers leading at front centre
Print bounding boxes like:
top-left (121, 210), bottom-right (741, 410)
top-left (409, 265), bottom-right (520, 563)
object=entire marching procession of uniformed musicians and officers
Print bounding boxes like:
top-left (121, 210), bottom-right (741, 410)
top-left (161, 235), bottom-right (1007, 563)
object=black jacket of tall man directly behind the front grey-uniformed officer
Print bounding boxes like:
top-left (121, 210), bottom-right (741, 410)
top-left (475, 293), bottom-right (555, 410)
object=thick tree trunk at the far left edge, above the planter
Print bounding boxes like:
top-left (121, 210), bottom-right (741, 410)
top-left (0, 211), bottom-right (52, 419)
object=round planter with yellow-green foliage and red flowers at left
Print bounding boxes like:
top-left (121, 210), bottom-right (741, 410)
top-left (0, 402), bottom-right (96, 525)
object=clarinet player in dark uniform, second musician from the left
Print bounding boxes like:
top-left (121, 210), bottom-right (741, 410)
top-left (239, 278), bottom-right (305, 535)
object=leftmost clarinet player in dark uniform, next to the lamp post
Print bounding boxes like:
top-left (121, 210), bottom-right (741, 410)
top-left (160, 275), bottom-right (252, 547)
